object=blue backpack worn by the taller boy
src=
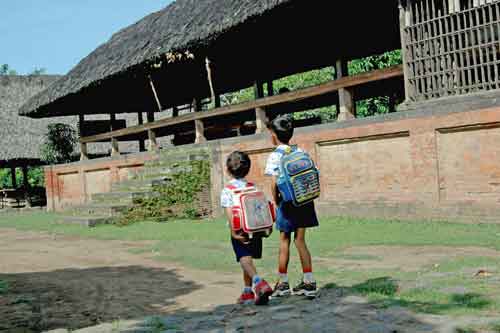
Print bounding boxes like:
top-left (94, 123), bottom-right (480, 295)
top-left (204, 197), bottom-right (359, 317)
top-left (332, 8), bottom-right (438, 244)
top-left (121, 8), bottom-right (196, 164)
top-left (276, 146), bottom-right (320, 207)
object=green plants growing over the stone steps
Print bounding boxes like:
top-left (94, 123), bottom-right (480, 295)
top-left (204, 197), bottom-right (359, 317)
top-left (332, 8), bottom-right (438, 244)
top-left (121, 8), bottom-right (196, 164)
top-left (117, 159), bottom-right (210, 225)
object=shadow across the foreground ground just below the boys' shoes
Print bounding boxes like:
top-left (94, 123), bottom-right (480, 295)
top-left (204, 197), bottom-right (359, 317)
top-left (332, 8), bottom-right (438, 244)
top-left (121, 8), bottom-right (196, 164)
top-left (78, 278), bottom-right (460, 333)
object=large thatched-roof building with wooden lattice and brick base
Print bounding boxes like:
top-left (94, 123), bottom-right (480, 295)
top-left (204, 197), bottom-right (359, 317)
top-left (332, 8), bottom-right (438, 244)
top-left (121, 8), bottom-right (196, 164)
top-left (20, 0), bottom-right (500, 223)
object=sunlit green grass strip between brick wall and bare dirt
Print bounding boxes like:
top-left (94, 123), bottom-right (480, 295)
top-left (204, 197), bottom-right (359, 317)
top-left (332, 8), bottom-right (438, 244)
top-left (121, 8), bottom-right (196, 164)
top-left (0, 214), bottom-right (500, 315)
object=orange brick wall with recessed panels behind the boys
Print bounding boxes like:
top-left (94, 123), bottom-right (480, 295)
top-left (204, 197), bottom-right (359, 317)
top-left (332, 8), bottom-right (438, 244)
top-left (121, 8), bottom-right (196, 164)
top-left (47, 99), bottom-right (500, 222)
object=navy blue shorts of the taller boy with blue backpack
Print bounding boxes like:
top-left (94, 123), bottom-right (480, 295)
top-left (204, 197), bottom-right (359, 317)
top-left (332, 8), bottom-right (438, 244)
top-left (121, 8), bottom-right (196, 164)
top-left (276, 202), bottom-right (319, 233)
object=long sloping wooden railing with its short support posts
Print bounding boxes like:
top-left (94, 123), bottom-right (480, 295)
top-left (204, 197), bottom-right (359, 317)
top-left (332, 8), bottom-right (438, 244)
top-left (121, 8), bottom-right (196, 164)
top-left (80, 65), bottom-right (403, 159)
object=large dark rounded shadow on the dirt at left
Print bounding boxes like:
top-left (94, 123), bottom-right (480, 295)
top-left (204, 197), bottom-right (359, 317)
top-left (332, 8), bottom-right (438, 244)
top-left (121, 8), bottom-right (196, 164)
top-left (0, 266), bottom-right (200, 332)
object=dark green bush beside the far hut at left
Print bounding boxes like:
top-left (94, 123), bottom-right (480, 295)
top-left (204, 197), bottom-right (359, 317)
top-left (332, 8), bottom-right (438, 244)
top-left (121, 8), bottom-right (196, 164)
top-left (40, 124), bottom-right (77, 164)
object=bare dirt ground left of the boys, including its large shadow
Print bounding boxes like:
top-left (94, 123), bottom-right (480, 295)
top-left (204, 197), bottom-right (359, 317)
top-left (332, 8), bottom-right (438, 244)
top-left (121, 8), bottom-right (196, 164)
top-left (0, 229), bottom-right (240, 331)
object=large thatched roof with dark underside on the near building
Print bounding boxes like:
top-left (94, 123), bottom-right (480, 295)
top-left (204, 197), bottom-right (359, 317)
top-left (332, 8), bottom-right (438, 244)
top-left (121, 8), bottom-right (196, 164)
top-left (20, 0), bottom-right (400, 117)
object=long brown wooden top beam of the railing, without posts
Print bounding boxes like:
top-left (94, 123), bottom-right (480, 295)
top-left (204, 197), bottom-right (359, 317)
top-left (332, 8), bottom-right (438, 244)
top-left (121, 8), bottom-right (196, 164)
top-left (81, 65), bottom-right (403, 142)
